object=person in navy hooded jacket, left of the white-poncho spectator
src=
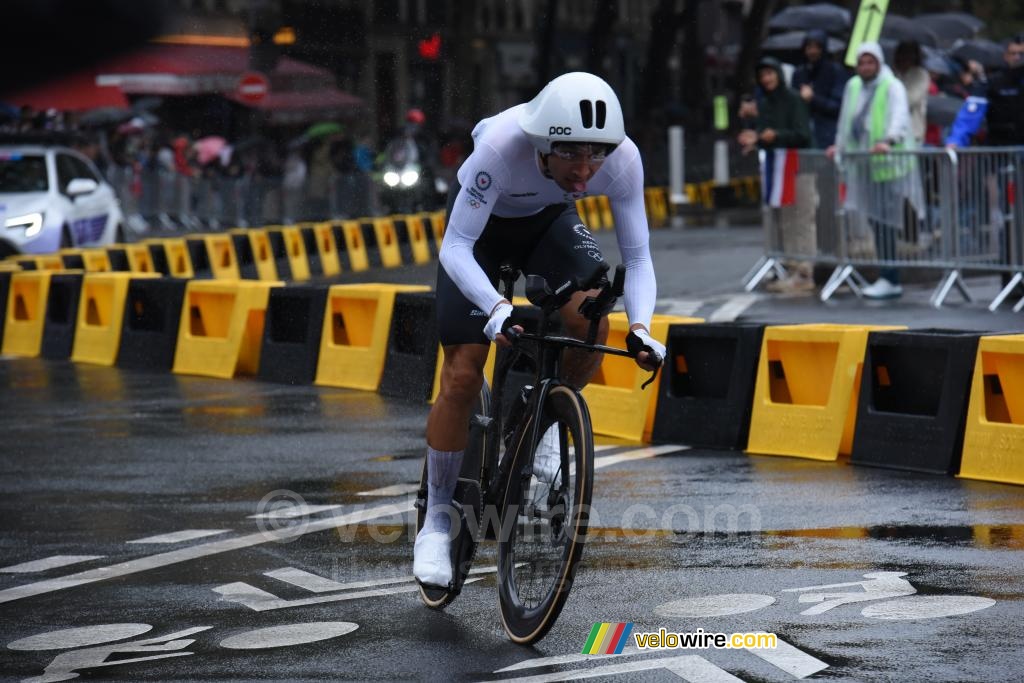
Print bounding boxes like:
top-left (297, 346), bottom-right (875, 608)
top-left (793, 30), bottom-right (848, 150)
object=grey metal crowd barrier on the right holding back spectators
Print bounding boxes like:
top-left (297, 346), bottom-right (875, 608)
top-left (744, 147), bottom-right (1024, 311)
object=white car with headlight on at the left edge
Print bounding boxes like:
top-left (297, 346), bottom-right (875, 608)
top-left (0, 144), bottom-right (124, 258)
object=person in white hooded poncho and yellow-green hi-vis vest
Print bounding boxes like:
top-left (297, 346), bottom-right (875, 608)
top-left (826, 42), bottom-right (921, 299)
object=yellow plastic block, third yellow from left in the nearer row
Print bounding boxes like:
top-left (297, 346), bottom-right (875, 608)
top-left (173, 280), bottom-right (284, 379)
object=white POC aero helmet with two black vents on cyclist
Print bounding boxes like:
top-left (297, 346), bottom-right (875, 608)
top-left (519, 72), bottom-right (626, 155)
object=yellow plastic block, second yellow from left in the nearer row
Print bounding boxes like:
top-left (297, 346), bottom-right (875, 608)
top-left (71, 272), bottom-right (160, 366)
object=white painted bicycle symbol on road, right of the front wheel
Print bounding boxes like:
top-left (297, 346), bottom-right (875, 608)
top-left (654, 571), bottom-right (995, 621)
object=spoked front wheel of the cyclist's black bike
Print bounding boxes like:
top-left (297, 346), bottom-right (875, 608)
top-left (498, 385), bottom-right (594, 645)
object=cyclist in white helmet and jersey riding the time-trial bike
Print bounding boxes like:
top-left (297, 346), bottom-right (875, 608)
top-left (413, 72), bottom-right (665, 588)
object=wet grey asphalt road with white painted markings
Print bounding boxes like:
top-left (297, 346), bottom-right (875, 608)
top-left (0, 222), bottom-right (1024, 681)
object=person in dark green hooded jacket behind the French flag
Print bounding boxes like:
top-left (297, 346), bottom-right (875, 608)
top-left (738, 57), bottom-right (817, 293)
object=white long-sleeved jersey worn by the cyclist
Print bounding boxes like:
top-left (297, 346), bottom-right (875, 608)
top-left (438, 104), bottom-right (656, 329)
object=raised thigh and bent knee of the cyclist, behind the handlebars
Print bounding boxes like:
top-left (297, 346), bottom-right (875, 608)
top-left (526, 204), bottom-right (608, 389)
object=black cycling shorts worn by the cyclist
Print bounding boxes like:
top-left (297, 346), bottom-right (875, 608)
top-left (437, 183), bottom-right (604, 346)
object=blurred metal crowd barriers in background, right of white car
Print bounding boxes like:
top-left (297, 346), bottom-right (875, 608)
top-left (106, 166), bottom-right (375, 232)
